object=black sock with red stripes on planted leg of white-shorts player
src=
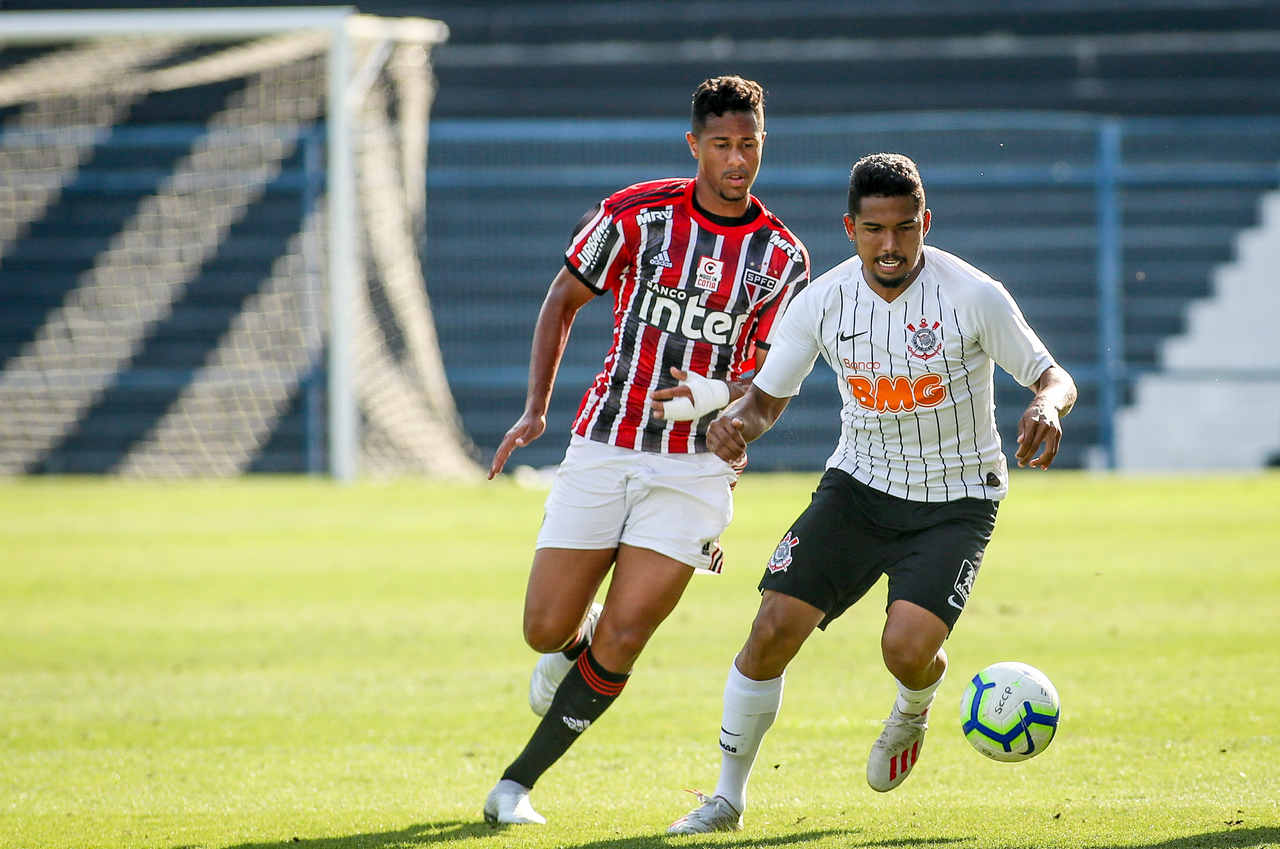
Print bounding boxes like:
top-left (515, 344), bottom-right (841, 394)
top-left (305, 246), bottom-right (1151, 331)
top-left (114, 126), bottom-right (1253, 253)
top-left (502, 649), bottom-right (627, 788)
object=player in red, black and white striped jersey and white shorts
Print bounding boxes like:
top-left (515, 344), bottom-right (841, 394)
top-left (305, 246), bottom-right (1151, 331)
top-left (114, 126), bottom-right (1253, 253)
top-left (484, 77), bottom-right (809, 825)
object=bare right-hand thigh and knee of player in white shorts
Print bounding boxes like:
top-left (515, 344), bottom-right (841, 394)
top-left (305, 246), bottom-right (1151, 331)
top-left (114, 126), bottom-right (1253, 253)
top-left (591, 544), bottom-right (694, 672)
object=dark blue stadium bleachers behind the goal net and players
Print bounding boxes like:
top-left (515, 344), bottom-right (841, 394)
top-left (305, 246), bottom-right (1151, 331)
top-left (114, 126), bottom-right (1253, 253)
top-left (0, 0), bottom-right (1280, 473)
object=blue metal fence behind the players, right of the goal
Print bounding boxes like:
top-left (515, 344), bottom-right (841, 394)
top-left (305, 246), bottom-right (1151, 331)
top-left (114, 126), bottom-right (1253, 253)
top-left (429, 113), bottom-right (1280, 466)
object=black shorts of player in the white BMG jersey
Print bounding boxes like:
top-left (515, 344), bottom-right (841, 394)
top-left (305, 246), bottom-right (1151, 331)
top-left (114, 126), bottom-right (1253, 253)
top-left (760, 469), bottom-right (998, 630)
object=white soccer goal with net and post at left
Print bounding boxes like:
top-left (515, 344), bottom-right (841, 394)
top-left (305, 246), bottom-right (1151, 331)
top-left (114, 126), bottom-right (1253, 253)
top-left (0, 9), bottom-right (477, 479)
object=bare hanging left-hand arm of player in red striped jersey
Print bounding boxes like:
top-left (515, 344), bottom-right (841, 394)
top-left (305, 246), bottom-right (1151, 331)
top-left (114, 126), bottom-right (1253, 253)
top-left (489, 268), bottom-right (595, 480)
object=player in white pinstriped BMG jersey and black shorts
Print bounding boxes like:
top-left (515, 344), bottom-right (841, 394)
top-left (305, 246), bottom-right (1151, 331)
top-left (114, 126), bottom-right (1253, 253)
top-left (668, 154), bottom-right (1075, 834)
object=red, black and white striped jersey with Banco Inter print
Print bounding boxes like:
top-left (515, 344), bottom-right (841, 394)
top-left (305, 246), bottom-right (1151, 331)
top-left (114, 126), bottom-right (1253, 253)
top-left (564, 178), bottom-right (809, 453)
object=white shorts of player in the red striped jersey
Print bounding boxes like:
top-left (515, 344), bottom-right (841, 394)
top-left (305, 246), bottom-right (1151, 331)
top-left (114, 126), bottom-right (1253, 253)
top-left (538, 434), bottom-right (737, 571)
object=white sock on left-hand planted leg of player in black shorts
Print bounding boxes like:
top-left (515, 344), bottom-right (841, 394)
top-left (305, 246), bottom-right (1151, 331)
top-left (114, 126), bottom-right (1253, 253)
top-left (712, 663), bottom-right (786, 813)
